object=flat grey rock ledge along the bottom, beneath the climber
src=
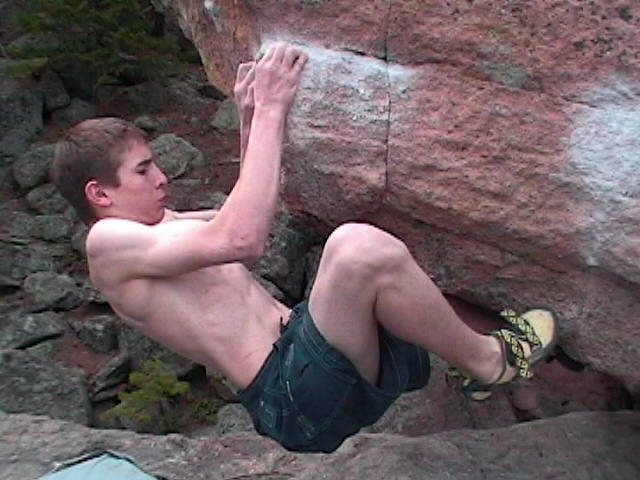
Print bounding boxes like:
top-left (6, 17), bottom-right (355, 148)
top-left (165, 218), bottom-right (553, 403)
top-left (0, 412), bottom-right (640, 480)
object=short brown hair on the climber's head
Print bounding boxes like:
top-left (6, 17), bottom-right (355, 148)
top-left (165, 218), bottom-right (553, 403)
top-left (51, 117), bottom-right (147, 224)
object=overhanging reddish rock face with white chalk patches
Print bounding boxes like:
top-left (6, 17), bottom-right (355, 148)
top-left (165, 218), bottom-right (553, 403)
top-left (169, 0), bottom-right (640, 397)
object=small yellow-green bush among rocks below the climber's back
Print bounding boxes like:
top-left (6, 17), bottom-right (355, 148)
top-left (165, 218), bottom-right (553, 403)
top-left (104, 359), bottom-right (189, 433)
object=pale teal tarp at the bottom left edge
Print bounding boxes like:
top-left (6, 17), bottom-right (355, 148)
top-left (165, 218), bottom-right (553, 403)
top-left (38, 452), bottom-right (157, 480)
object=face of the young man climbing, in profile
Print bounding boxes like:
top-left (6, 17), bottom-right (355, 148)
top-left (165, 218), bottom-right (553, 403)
top-left (103, 141), bottom-right (169, 225)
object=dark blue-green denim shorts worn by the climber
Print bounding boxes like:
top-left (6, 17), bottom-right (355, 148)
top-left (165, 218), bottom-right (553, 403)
top-left (238, 301), bottom-right (430, 453)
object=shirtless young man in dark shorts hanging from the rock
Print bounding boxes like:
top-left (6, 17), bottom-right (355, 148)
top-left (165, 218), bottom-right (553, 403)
top-left (52, 44), bottom-right (555, 452)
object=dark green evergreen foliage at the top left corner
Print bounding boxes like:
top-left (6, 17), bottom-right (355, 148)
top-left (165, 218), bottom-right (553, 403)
top-left (10, 0), bottom-right (185, 89)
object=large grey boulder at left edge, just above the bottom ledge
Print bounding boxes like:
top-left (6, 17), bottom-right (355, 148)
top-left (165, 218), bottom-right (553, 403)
top-left (0, 350), bottom-right (91, 425)
